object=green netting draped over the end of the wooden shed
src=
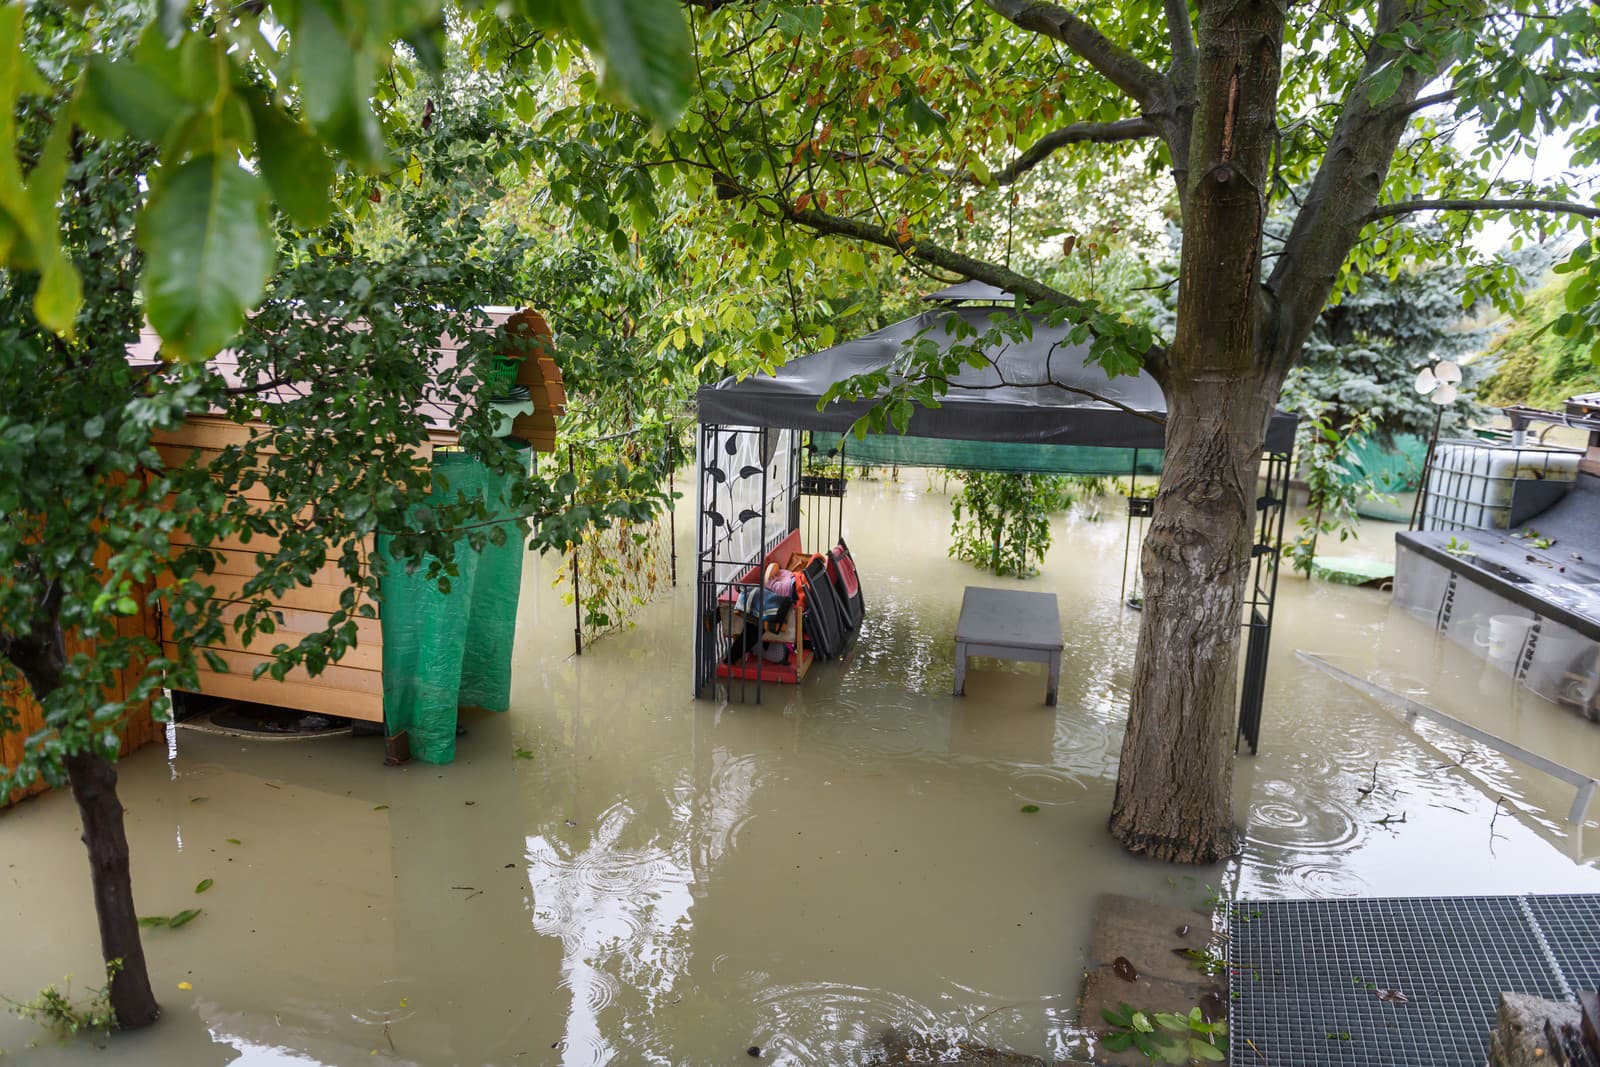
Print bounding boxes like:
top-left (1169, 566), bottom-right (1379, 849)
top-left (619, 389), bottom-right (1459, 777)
top-left (378, 453), bottom-right (526, 763)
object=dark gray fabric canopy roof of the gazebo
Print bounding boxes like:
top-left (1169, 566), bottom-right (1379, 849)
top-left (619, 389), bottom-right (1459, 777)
top-left (699, 300), bottom-right (1294, 460)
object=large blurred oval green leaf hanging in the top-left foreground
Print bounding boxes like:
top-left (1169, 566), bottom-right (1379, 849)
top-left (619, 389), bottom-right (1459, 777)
top-left (139, 155), bottom-right (274, 360)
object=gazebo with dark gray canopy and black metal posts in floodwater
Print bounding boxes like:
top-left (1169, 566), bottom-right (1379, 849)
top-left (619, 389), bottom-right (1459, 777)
top-left (694, 282), bottom-right (1296, 752)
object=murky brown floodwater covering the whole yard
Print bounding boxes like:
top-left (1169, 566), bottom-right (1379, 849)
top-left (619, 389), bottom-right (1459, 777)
top-left (0, 474), bottom-right (1600, 1065)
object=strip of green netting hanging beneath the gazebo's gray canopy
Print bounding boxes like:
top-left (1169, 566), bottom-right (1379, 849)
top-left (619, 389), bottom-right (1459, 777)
top-left (811, 430), bottom-right (1162, 475)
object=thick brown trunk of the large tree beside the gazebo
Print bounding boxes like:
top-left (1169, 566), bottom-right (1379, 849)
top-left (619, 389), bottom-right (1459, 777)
top-left (1110, 0), bottom-right (1283, 864)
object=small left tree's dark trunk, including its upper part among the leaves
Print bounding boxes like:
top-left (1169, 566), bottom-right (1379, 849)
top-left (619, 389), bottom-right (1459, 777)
top-left (5, 617), bottom-right (162, 1030)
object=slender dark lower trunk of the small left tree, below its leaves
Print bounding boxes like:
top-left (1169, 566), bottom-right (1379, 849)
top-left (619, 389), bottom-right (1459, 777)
top-left (67, 752), bottom-right (162, 1030)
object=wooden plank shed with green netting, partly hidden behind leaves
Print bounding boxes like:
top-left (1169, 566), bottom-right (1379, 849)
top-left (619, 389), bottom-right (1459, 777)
top-left (128, 307), bottom-right (566, 761)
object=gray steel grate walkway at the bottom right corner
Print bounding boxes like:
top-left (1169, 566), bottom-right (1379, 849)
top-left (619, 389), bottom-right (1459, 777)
top-left (1227, 894), bottom-right (1600, 1067)
